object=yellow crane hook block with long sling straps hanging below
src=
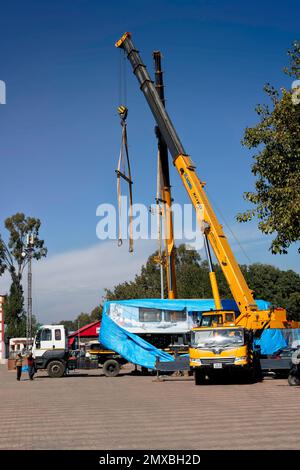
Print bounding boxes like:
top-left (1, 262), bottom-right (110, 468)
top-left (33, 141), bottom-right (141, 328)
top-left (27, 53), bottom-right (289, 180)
top-left (115, 105), bottom-right (133, 253)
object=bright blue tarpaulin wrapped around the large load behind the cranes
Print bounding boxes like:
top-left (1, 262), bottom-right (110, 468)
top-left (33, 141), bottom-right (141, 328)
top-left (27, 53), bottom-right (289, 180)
top-left (99, 299), bottom-right (270, 369)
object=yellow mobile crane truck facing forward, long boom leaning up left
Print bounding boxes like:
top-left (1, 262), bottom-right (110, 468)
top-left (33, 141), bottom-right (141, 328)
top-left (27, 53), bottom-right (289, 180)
top-left (115, 32), bottom-right (292, 384)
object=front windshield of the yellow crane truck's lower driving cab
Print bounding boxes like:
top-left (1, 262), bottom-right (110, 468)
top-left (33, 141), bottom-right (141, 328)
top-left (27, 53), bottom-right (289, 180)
top-left (192, 328), bottom-right (244, 347)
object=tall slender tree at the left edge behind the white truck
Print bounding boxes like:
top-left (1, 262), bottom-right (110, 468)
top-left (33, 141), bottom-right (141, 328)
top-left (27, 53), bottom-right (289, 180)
top-left (0, 213), bottom-right (47, 337)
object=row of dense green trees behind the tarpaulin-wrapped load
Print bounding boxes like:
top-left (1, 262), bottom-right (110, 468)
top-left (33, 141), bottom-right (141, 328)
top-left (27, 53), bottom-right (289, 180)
top-left (106, 245), bottom-right (300, 320)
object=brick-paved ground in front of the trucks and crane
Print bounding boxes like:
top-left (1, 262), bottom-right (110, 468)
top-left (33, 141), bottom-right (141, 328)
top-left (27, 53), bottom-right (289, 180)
top-left (0, 366), bottom-right (300, 449)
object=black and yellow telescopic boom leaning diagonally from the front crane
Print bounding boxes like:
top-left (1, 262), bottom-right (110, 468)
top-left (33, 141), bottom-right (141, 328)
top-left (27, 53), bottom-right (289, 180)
top-left (115, 32), bottom-right (286, 329)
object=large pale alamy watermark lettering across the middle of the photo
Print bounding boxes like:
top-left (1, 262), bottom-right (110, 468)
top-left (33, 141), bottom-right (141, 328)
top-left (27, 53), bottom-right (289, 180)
top-left (96, 196), bottom-right (203, 250)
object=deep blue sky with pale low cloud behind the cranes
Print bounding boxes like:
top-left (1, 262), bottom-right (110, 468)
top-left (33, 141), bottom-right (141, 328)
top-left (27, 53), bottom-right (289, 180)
top-left (0, 0), bottom-right (300, 317)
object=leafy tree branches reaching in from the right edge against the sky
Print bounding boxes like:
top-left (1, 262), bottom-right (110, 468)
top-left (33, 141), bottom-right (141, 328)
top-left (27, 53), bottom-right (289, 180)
top-left (237, 41), bottom-right (300, 253)
